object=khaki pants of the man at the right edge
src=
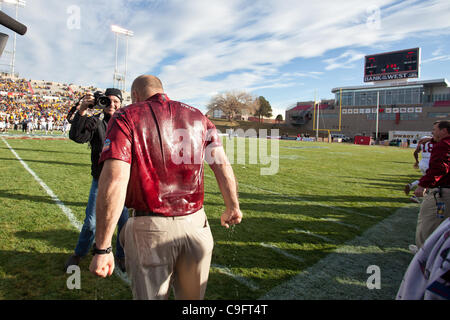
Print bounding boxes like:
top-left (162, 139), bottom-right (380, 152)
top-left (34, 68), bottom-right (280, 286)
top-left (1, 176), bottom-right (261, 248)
top-left (416, 188), bottom-right (450, 248)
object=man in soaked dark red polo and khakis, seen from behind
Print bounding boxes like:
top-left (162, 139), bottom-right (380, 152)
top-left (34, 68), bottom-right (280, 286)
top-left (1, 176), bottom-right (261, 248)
top-left (90, 75), bottom-right (242, 299)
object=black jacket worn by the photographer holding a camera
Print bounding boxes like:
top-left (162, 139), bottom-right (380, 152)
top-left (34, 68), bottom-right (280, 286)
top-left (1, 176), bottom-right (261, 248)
top-left (69, 112), bottom-right (111, 180)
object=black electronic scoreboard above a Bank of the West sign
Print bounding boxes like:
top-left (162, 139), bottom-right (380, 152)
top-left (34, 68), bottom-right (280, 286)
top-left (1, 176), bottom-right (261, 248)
top-left (364, 48), bottom-right (420, 82)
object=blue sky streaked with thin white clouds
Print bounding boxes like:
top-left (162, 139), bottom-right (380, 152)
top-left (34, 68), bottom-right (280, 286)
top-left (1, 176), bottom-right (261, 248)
top-left (0, 0), bottom-right (450, 116)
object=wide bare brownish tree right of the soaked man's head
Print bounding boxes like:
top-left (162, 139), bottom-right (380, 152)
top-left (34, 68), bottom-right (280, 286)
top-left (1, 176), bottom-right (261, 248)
top-left (206, 91), bottom-right (257, 121)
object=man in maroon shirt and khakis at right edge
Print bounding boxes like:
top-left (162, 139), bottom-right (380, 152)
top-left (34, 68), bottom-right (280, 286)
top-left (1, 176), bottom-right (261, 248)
top-left (414, 120), bottom-right (450, 248)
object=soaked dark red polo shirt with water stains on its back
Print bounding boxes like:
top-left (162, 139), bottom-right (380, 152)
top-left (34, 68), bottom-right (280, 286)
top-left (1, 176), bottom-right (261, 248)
top-left (100, 94), bottom-right (222, 216)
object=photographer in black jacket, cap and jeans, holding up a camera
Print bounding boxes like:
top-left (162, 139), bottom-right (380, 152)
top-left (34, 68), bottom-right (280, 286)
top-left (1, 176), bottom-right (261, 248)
top-left (64, 88), bottom-right (128, 272)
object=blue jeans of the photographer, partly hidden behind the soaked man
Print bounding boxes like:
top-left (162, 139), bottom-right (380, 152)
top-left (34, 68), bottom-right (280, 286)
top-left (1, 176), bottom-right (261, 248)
top-left (75, 179), bottom-right (128, 258)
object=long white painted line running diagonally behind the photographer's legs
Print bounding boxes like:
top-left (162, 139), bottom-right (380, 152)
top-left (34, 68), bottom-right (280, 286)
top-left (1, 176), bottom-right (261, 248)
top-left (1, 137), bottom-right (131, 284)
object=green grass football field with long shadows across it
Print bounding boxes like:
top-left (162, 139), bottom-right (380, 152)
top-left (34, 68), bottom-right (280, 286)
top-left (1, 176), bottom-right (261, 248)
top-left (0, 137), bottom-right (420, 300)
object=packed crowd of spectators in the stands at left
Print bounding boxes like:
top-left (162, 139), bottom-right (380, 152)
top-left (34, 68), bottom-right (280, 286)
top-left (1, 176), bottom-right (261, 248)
top-left (0, 76), bottom-right (101, 134)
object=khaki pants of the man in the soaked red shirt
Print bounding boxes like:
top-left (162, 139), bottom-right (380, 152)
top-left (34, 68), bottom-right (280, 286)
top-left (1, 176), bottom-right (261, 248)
top-left (120, 209), bottom-right (214, 300)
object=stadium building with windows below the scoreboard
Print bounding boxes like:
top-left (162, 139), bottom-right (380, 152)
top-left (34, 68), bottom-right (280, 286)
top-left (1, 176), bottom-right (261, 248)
top-left (286, 47), bottom-right (450, 140)
